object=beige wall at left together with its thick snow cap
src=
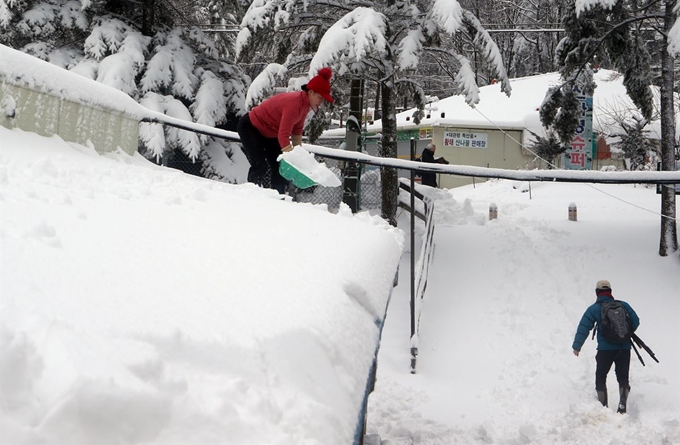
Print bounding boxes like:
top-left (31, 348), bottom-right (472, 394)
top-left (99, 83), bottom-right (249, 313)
top-left (0, 45), bottom-right (139, 154)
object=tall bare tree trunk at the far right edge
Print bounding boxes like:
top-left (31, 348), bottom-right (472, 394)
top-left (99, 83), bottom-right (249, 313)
top-left (659, 0), bottom-right (678, 256)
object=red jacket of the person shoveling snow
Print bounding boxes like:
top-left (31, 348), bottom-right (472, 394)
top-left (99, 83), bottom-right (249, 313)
top-left (249, 91), bottom-right (311, 148)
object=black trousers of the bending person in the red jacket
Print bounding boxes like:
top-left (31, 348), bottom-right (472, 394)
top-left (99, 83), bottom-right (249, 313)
top-left (236, 113), bottom-right (288, 193)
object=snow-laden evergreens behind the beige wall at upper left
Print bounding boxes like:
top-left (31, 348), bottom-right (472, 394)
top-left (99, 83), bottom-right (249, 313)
top-left (0, 0), bottom-right (249, 182)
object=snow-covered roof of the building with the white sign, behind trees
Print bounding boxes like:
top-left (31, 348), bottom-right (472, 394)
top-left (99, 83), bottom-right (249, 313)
top-left (325, 69), bottom-right (661, 139)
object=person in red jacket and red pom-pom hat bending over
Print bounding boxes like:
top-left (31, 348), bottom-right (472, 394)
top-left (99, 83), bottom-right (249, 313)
top-left (236, 68), bottom-right (333, 193)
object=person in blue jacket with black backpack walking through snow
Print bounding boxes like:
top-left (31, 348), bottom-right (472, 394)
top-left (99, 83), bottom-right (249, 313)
top-left (571, 280), bottom-right (640, 413)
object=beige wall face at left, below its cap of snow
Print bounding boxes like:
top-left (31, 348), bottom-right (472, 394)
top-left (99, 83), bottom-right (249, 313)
top-left (0, 78), bottom-right (139, 155)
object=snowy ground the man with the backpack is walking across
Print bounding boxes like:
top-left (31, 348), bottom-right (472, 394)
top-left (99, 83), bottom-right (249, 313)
top-left (368, 181), bottom-right (680, 445)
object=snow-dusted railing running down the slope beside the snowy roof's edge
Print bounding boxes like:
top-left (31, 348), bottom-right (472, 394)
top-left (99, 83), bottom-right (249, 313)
top-left (399, 178), bottom-right (434, 374)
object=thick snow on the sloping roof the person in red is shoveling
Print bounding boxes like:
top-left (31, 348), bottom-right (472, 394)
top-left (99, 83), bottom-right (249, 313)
top-left (0, 127), bottom-right (403, 445)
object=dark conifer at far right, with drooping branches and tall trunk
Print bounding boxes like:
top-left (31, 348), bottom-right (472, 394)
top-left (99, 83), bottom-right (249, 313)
top-left (541, 0), bottom-right (678, 256)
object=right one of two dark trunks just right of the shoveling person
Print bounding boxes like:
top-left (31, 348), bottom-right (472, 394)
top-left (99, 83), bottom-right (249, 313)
top-left (380, 78), bottom-right (399, 227)
